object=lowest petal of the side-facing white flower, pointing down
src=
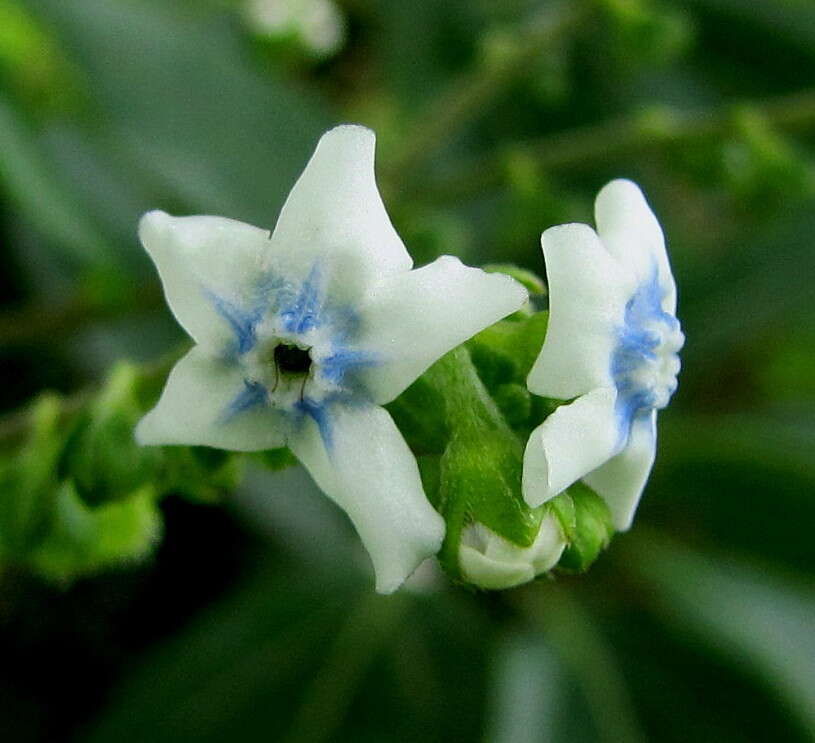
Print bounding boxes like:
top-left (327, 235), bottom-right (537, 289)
top-left (583, 411), bottom-right (657, 531)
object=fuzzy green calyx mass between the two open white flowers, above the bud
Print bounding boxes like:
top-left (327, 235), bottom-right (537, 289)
top-left (388, 290), bottom-right (613, 582)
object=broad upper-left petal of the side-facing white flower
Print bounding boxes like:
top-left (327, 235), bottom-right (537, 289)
top-left (527, 224), bottom-right (632, 400)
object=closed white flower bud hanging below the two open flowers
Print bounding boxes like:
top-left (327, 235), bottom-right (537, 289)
top-left (458, 513), bottom-right (566, 590)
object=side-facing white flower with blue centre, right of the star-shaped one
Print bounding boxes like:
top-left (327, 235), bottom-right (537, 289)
top-left (523, 180), bottom-right (684, 530)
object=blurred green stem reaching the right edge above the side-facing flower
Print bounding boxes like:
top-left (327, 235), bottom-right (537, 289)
top-left (422, 90), bottom-right (815, 201)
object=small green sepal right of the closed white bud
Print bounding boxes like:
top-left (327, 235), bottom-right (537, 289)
top-left (548, 482), bottom-right (614, 573)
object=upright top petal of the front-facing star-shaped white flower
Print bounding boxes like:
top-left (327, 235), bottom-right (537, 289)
top-left (269, 125), bottom-right (413, 286)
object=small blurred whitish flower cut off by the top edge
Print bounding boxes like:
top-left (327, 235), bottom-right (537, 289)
top-left (245, 0), bottom-right (345, 58)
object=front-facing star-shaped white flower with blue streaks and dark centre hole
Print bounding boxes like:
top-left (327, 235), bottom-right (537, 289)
top-left (137, 126), bottom-right (526, 593)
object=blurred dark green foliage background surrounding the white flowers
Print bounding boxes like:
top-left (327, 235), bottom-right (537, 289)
top-left (0, 0), bottom-right (815, 743)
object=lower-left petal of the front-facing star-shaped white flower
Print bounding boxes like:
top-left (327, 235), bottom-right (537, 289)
top-left (136, 346), bottom-right (285, 451)
